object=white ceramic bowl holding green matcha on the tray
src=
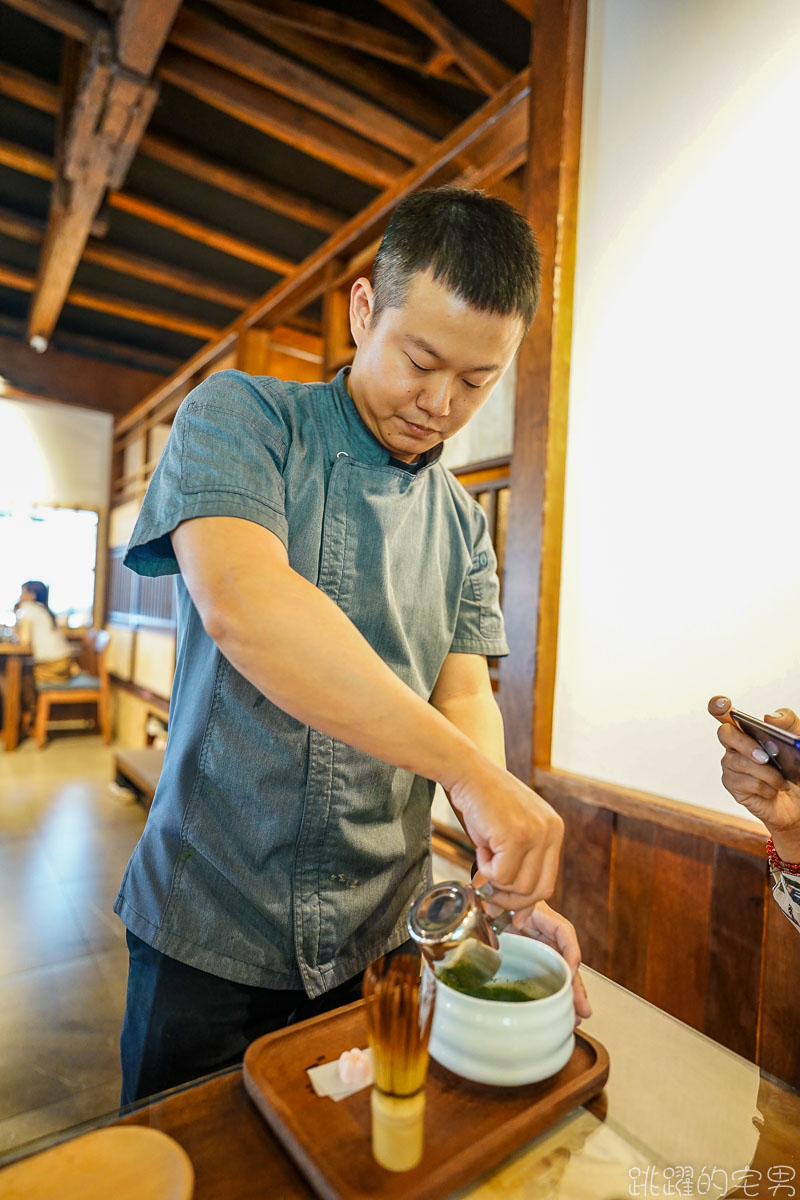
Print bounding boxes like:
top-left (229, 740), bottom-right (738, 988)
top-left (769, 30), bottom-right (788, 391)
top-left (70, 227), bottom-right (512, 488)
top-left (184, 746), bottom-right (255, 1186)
top-left (425, 934), bottom-right (575, 1087)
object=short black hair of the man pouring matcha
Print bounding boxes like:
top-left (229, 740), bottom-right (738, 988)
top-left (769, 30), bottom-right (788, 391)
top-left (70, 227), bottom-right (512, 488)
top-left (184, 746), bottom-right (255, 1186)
top-left (372, 187), bottom-right (541, 330)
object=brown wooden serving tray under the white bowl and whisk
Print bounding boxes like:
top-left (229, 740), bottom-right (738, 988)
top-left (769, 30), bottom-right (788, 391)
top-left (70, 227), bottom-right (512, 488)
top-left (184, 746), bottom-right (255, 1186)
top-left (243, 1000), bottom-right (608, 1200)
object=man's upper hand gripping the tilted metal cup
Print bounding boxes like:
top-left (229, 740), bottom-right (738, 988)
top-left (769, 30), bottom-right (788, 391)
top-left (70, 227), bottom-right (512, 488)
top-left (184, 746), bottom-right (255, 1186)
top-left (447, 755), bottom-right (564, 912)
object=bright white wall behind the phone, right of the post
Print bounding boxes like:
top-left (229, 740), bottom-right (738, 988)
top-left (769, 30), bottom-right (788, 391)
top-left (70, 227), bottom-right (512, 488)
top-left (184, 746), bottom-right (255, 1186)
top-left (553, 0), bottom-right (800, 811)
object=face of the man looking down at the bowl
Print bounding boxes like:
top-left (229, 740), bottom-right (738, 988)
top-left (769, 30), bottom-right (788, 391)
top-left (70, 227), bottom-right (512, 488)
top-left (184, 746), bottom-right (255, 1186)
top-left (348, 271), bottom-right (523, 462)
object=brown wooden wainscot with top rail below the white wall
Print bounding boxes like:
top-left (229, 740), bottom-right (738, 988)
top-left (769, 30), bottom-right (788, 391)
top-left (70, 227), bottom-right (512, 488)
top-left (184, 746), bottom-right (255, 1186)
top-left (527, 769), bottom-right (800, 1087)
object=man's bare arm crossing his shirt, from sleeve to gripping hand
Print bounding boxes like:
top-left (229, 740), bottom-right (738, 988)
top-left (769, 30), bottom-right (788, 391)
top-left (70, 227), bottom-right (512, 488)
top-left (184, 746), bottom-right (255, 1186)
top-left (172, 517), bottom-right (563, 908)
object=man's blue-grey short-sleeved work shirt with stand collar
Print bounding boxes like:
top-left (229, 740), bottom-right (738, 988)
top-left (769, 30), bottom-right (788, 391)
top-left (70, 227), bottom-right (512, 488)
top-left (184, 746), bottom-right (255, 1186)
top-left (115, 371), bottom-right (507, 996)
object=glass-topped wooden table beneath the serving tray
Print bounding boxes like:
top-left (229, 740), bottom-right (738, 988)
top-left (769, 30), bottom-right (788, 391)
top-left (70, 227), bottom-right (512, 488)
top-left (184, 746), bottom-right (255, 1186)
top-left (0, 968), bottom-right (800, 1200)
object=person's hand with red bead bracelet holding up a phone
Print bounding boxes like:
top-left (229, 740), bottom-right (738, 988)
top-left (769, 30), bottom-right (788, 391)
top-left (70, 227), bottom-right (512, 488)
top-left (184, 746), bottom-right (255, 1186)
top-left (709, 696), bottom-right (800, 930)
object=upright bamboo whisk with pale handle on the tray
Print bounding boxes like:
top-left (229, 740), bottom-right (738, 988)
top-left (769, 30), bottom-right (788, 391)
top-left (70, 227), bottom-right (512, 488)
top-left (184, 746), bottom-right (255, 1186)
top-left (363, 954), bottom-right (435, 1171)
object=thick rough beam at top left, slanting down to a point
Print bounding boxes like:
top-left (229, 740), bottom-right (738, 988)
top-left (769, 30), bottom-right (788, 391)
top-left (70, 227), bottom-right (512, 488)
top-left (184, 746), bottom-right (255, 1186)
top-left (25, 0), bottom-right (180, 349)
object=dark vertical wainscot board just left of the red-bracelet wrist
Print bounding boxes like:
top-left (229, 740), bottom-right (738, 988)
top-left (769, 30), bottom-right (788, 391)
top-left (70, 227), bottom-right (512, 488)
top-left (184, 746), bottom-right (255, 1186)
top-left (703, 846), bottom-right (767, 1061)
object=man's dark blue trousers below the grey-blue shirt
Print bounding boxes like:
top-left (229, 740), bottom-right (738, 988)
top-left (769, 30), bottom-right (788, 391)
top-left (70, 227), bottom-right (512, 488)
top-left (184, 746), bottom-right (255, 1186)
top-left (120, 931), bottom-right (400, 1104)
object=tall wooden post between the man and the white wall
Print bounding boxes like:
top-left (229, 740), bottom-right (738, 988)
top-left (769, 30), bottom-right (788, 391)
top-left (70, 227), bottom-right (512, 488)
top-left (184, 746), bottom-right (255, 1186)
top-left (499, 0), bottom-right (587, 782)
